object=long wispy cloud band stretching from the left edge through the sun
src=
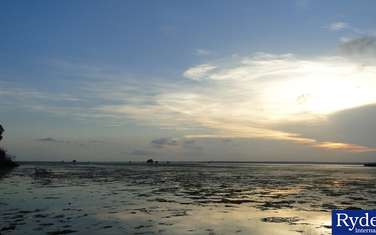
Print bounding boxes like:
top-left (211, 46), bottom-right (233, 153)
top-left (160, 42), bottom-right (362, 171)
top-left (0, 40), bottom-right (376, 152)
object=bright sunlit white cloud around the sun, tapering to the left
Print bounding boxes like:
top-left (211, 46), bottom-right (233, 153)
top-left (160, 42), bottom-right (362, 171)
top-left (98, 49), bottom-right (376, 152)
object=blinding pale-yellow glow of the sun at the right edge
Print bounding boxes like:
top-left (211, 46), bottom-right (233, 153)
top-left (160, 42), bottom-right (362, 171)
top-left (261, 57), bottom-right (376, 120)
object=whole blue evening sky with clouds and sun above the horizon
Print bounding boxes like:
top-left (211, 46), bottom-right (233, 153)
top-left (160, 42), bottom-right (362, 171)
top-left (0, 0), bottom-right (376, 162)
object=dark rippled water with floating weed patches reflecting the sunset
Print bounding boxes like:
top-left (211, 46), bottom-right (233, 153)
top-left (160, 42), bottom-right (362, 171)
top-left (0, 163), bottom-right (376, 235)
